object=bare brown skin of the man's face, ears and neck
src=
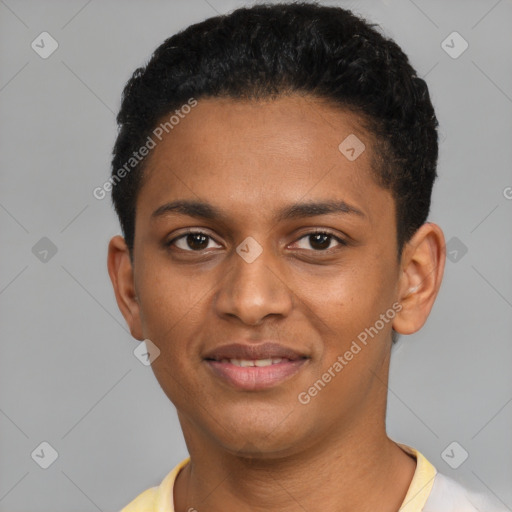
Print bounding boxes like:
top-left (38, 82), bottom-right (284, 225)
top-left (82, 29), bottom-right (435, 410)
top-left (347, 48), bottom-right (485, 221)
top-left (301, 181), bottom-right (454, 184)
top-left (108, 95), bottom-right (445, 512)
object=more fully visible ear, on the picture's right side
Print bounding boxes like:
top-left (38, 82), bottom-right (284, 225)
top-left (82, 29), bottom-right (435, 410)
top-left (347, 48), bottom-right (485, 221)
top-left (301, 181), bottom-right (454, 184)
top-left (393, 222), bottom-right (446, 334)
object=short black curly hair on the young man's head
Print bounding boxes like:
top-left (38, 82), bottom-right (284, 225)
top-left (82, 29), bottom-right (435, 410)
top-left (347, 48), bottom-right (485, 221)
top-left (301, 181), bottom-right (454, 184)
top-left (110, 2), bottom-right (438, 255)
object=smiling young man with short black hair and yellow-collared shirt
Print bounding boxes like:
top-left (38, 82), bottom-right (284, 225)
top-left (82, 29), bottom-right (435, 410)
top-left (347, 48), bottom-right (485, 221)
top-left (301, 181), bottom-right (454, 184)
top-left (108, 4), bottom-right (504, 512)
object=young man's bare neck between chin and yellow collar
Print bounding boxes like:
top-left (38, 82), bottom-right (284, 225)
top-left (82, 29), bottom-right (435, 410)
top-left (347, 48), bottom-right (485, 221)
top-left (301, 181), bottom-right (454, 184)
top-left (174, 420), bottom-right (416, 512)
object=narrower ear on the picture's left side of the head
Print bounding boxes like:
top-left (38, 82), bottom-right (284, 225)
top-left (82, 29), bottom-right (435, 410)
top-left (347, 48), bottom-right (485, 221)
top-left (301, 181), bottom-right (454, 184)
top-left (107, 236), bottom-right (144, 341)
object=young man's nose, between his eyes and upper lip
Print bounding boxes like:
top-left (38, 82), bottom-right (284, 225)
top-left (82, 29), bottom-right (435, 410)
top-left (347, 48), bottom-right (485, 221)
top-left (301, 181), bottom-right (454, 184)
top-left (215, 238), bottom-right (293, 326)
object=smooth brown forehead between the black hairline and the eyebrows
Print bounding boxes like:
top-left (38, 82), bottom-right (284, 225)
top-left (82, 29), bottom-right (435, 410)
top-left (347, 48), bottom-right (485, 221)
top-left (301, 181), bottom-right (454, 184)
top-left (137, 95), bottom-right (393, 229)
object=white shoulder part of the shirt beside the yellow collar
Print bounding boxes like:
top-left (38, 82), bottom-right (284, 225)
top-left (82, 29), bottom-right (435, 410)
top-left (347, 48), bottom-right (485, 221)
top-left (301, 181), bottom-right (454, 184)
top-left (423, 473), bottom-right (506, 512)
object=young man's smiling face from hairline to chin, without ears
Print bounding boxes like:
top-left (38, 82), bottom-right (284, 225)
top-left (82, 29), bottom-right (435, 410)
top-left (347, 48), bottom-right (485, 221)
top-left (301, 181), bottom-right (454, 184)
top-left (107, 96), bottom-right (440, 457)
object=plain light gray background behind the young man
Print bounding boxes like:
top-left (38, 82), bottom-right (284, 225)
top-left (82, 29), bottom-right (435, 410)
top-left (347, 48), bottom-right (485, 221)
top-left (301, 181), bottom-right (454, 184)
top-left (0, 0), bottom-right (512, 512)
